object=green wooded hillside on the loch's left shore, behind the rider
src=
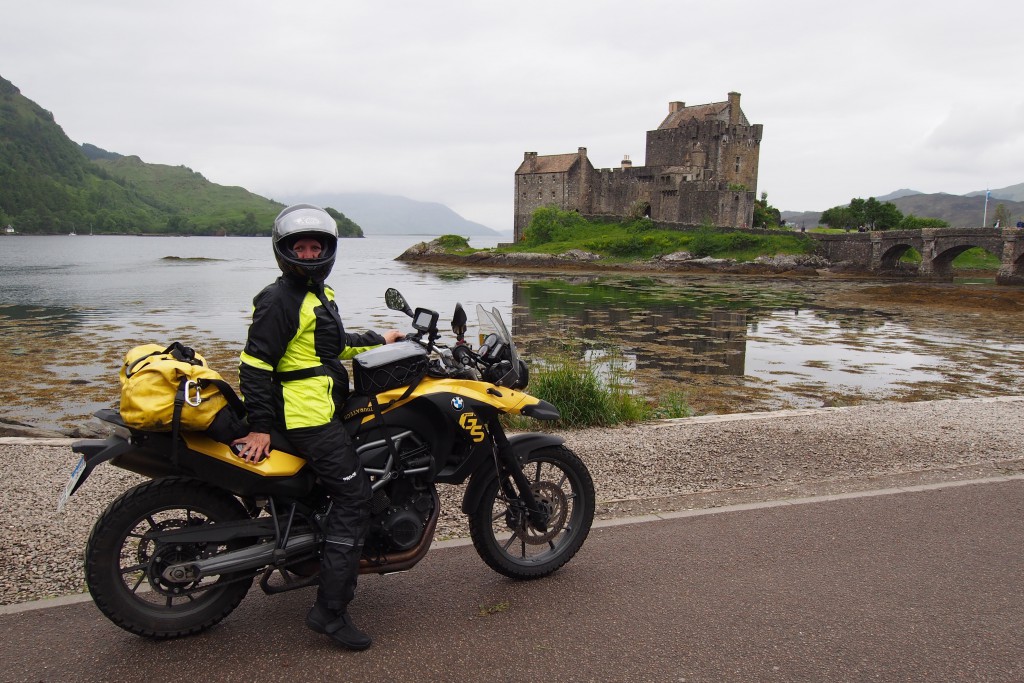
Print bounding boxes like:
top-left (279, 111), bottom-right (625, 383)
top-left (0, 77), bottom-right (362, 237)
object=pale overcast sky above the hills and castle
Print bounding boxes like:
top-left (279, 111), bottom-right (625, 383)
top-left (0, 0), bottom-right (1024, 229)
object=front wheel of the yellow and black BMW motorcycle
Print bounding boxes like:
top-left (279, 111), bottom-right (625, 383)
top-left (469, 445), bottom-right (594, 579)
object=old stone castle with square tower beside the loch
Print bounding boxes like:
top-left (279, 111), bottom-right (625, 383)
top-left (515, 92), bottom-right (763, 242)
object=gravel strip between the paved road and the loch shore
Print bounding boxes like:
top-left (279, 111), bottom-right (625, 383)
top-left (0, 396), bottom-right (1024, 604)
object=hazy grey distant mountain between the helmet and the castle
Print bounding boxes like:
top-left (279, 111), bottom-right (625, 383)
top-left (288, 193), bottom-right (502, 237)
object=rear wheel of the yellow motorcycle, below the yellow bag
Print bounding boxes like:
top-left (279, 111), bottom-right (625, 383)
top-left (85, 478), bottom-right (252, 638)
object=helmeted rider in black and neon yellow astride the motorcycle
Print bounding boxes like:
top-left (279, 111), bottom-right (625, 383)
top-left (232, 204), bottom-right (401, 650)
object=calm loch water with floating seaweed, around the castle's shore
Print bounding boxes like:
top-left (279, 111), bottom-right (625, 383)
top-left (0, 234), bottom-right (1024, 430)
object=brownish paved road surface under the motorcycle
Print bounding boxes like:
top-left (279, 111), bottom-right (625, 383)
top-left (0, 477), bottom-right (1024, 682)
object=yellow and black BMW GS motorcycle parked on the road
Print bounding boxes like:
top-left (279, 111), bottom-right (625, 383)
top-left (59, 289), bottom-right (595, 638)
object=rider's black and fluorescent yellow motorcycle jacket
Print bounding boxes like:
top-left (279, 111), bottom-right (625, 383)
top-left (239, 275), bottom-right (384, 433)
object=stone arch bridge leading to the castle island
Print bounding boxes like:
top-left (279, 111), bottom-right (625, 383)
top-left (811, 227), bottom-right (1024, 285)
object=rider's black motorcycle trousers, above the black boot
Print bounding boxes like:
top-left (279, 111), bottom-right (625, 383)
top-left (287, 421), bottom-right (372, 611)
